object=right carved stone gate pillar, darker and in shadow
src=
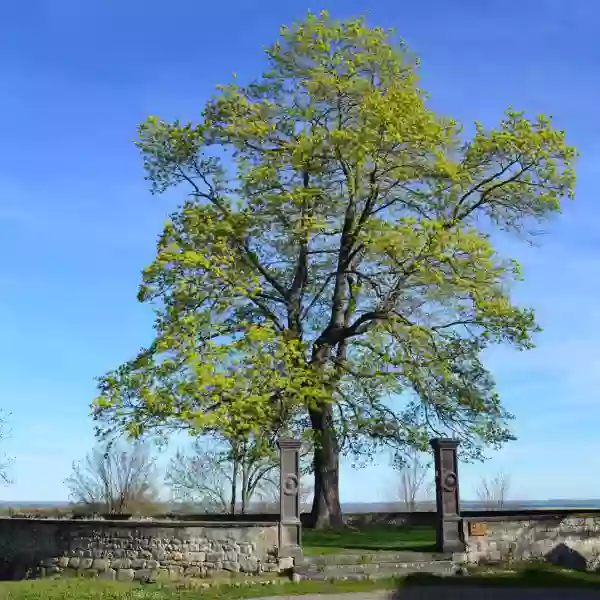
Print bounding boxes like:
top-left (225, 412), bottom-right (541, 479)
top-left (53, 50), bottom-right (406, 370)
top-left (430, 438), bottom-right (465, 552)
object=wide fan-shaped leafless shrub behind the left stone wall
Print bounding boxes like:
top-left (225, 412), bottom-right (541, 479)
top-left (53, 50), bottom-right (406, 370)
top-left (65, 441), bottom-right (158, 514)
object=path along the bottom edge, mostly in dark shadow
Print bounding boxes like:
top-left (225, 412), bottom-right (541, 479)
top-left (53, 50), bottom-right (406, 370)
top-left (255, 586), bottom-right (600, 600)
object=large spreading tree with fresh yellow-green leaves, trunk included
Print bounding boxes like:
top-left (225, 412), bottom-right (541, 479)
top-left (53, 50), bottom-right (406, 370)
top-left (95, 13), bottom-right (576, 526)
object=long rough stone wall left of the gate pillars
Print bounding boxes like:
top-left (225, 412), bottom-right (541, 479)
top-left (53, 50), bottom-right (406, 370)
top-left (0, 518), bottom-right (283, 581)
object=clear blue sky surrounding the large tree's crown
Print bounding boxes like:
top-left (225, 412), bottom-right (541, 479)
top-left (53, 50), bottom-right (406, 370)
top-left (0, 0), bottom-right (600, 501)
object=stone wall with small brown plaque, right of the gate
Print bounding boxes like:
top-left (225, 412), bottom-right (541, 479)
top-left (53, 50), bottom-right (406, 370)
top-left (463, 511), bottom-right (600, 570)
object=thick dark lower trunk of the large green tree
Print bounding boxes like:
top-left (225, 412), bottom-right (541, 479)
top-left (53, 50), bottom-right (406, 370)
top-left (309, 405), bottom-right (344, 529)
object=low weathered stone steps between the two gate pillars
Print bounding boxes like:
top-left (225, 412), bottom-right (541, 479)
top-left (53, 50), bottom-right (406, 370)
top-left (294, 561), bottom-right (456, 581)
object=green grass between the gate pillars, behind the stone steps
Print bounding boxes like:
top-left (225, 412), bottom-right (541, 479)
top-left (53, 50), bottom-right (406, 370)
top-left (302, 526), bottom-right (435, 556)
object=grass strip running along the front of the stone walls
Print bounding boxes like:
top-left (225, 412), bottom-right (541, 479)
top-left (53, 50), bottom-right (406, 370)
top-left (0, 565), bottom-right (600, 600)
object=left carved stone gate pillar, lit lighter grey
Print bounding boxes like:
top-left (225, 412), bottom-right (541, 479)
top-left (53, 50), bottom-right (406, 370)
top-left (277, 439), bottom-right (302, 558)
